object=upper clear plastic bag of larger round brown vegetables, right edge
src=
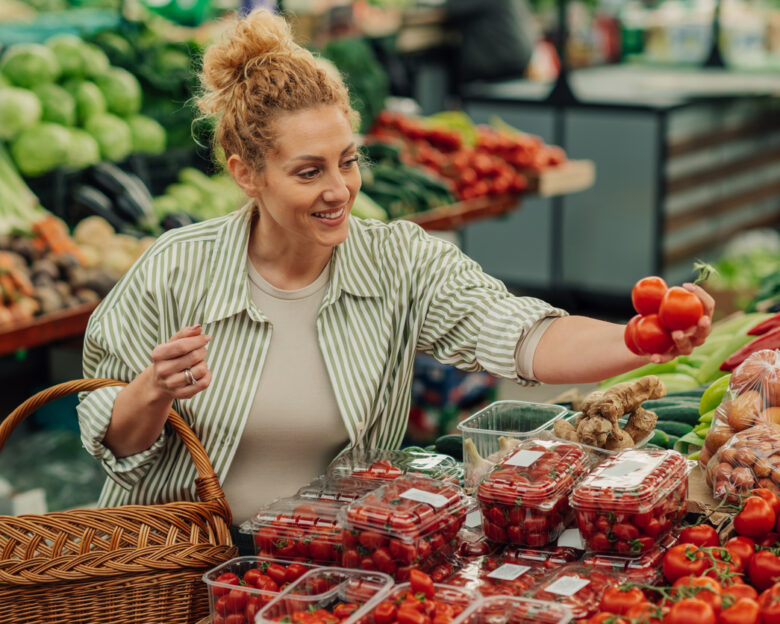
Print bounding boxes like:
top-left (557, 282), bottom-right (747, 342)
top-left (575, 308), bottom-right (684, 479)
top-left (699, 349), bottom-right (780, 469)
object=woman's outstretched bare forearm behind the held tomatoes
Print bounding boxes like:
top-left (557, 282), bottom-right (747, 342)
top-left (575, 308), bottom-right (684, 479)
top-left (534, 316), bottom-right (650, 384)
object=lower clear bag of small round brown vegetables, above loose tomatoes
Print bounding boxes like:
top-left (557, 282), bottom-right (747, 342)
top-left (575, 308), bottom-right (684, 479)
top-left (706, 425), bottom-right (780, 503)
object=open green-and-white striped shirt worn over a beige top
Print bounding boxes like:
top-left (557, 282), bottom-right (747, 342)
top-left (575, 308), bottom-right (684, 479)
top-left (78, 207), bottom-right (565, 506)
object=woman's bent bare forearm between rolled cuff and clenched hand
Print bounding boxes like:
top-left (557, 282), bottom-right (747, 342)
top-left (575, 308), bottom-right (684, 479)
top-left (103, 366), bottom-right (173, 457)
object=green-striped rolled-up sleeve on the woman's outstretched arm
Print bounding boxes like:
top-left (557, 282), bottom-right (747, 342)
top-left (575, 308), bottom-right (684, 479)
top-left (411, 224), bottom-right (566, 385)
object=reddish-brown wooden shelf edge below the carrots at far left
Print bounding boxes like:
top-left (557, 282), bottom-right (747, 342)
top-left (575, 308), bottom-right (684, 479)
top-left (0, 303), bottom-right (97, 356)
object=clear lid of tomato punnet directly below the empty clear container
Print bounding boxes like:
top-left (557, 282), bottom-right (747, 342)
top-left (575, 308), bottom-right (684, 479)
top-left (477, 440), bottom-right (587, 511)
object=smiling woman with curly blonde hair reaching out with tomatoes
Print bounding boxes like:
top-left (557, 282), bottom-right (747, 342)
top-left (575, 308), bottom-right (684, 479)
top-left (79, 11), bottom-right (713, 523)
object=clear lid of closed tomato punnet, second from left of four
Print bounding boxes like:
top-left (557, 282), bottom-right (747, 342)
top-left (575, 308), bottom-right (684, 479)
top-left (339, 475), bottom-right (470, 541)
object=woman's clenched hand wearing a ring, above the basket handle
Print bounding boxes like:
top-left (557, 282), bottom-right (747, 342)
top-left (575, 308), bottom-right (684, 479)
top-left (152, 325), bottom-right (211, 399)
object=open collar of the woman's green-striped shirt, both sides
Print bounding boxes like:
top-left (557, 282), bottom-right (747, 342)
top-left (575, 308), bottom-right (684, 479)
top-left (202, 212), bottom-right (382, 323)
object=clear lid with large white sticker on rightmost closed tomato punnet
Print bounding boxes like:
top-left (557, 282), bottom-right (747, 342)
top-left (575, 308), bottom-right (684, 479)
top-left (571, 449), bottom-right (692, 513)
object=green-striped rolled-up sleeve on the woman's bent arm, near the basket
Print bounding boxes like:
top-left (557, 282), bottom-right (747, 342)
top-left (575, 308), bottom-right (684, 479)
top-left (77, 254), bottom-right (166, 489)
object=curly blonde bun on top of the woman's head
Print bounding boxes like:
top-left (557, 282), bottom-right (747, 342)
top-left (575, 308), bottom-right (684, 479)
top-left (198, 9), bottom-right (298, 115)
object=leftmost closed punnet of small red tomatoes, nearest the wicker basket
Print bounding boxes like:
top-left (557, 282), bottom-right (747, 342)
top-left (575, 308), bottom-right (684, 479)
top-left (240, 497), bottom-right (343, 565)
